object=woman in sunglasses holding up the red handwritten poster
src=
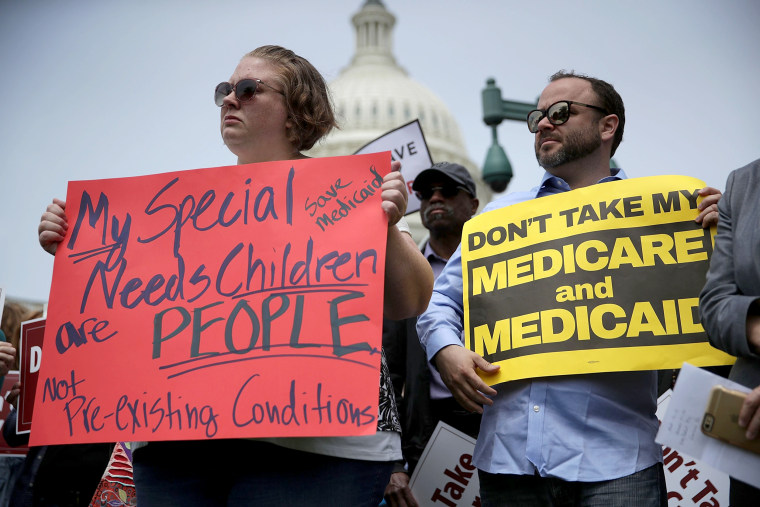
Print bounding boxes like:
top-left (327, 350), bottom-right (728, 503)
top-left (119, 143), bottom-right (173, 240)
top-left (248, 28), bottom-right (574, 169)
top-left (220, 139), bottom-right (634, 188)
top-left (38, 46), bottom-right (433, 507)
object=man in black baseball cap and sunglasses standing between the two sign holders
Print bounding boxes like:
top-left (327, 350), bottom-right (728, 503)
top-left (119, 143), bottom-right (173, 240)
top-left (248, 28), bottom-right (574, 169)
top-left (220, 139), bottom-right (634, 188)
top-left (383, 162), bottom-right (480, 506)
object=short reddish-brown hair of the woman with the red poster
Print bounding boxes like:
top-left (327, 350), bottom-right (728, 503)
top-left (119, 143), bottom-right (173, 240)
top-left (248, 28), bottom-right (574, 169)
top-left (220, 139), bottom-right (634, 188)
top-left (244, 46), bottom-right (338, 151)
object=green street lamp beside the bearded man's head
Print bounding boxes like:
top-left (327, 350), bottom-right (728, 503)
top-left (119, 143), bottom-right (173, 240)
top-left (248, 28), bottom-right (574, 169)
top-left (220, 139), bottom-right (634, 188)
top-left (482, 78), bottom-right (537, 192)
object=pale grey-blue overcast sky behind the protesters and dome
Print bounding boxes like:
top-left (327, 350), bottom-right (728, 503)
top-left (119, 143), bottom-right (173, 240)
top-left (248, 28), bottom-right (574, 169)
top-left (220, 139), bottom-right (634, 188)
top-left (0, 0), bottom-right (760, 300)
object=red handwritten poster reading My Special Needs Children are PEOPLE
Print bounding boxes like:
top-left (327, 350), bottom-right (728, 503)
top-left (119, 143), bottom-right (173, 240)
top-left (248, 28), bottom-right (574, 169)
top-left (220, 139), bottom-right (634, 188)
top-left (31, 153), bottom-right (391, 445)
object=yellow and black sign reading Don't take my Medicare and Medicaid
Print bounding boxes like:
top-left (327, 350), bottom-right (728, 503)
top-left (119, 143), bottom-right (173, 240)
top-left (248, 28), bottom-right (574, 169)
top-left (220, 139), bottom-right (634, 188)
top-left (462, 176), bottom-right (734, 385)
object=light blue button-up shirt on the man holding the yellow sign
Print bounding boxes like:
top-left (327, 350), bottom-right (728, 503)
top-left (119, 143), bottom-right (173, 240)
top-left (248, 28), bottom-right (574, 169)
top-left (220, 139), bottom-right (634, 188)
top-left (417, 169), bottom-right (662, 481)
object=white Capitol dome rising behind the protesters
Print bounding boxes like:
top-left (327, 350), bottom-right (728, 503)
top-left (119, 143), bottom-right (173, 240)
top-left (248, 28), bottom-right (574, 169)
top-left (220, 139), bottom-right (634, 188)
top-left (308, 0), bottom-right (491, 241)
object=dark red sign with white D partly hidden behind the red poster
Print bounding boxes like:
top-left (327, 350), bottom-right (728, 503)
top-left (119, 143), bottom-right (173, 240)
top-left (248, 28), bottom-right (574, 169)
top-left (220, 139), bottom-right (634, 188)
top-left (16, 319), bottom-right (47, 433)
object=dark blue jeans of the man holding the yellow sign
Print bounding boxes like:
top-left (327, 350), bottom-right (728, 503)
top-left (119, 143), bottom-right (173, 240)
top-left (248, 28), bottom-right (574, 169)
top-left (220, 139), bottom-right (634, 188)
top-left (478, 463), bottom-right (668, 507)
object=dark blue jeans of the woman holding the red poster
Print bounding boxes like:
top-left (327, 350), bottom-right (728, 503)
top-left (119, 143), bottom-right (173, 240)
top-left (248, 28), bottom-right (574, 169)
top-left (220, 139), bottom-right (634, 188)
top-left (133, 440), bottom-right (393, 507)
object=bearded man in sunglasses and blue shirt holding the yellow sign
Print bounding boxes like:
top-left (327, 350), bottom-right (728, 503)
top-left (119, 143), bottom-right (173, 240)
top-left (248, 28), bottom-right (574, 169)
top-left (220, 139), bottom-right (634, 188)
top-left (417, 72), bottom-right (720, 507)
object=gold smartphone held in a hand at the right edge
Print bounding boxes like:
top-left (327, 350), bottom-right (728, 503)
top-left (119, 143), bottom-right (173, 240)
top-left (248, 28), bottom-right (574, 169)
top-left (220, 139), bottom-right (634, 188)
top-left (702, 386), bottom-right (760, 454)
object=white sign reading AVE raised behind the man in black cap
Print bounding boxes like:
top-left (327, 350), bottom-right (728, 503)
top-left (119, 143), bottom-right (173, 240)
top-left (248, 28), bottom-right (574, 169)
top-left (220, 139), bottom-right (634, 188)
top-left (354, 120), bottom-right (433, 215)
